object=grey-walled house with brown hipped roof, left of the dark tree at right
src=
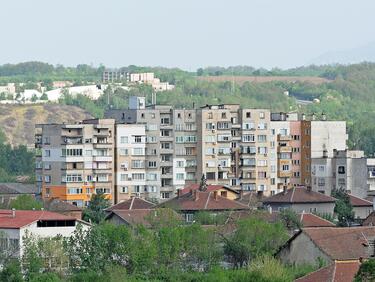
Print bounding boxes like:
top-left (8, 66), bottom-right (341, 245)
top-left (263, 187), bottom-right (336, 215)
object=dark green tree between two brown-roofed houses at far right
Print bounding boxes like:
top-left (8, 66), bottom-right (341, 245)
top-left (331, 189), bottom-right (354, 226)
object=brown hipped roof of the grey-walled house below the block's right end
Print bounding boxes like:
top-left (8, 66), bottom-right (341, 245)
top-left (263, 187), bottom-right (336, 204)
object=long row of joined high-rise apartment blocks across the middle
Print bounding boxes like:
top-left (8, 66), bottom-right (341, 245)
top-left (36, 97), bottom-right (347, 206)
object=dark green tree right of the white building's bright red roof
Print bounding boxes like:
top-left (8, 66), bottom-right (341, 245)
top-left (83, 193), bottom-right (110, 223)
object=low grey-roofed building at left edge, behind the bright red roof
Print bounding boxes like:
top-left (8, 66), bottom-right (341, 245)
top-left (0, 183), bottom-right (40, 206)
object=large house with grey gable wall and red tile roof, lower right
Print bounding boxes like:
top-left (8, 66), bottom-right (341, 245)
top-left (277, 226), bottom-right (375, 264)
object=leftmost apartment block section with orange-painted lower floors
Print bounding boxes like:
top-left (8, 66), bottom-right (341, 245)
top-left (36, 119), bottom-right (115, 206)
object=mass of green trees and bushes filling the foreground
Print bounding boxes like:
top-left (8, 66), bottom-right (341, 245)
top-left (0, 213), bottom-right (318, 282)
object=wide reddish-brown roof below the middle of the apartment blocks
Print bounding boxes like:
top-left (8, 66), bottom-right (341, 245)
top-left (159, 190), bottom-right (249, 211)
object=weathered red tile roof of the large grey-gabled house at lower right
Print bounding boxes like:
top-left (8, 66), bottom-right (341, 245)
top-left (302, 226), bottom-right (375, 260)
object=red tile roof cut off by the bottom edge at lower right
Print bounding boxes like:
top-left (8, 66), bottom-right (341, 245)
top-left (296, 260), bottom-right (360, 282)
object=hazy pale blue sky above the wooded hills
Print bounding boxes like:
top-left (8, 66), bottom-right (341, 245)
top-left (0, 0), bottom-right (375, 70)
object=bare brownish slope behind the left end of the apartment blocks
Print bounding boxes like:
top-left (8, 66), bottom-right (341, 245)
top-left (0, 104), bottom-right (92, 147)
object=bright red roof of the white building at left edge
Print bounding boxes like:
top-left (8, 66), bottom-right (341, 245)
top-left (0, 210), bottom-right (75, 229)
